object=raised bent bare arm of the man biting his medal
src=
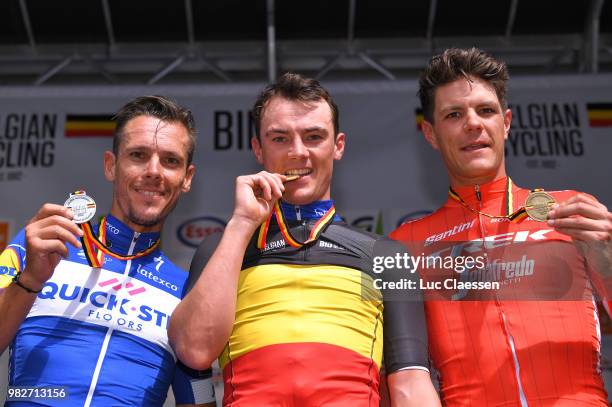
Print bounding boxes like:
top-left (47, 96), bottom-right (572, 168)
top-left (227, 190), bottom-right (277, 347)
top-left (168, 171), bottom-right (286, 370)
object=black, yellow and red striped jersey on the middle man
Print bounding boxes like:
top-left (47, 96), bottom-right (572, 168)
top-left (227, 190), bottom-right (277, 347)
top-left (189, 201), bottom-right (428, 407)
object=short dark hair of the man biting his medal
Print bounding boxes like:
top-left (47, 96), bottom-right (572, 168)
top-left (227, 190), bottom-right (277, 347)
top-left (251, 72), bottom-right (340, 139)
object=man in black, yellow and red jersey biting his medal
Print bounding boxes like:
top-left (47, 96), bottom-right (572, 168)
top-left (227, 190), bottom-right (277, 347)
top-left (169, 74), bottom-right (439, 406)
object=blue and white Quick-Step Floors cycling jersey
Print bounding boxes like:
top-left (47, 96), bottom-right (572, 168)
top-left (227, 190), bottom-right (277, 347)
top-left (0, 215), bottom-right (214, 406)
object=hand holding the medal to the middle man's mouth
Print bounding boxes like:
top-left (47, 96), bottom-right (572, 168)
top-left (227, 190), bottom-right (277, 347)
top-left (232, 171), bottom-right (287, 228)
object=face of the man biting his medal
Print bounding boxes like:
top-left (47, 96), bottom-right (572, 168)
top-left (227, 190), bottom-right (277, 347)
top-left (251, 97), bottom-right (345, 205)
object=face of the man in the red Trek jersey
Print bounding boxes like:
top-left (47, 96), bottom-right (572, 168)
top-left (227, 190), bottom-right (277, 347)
top-left (423, 79), bottom-right (512, 186)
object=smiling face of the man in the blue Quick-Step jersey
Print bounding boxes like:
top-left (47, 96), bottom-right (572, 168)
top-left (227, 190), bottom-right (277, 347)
top-left (104, 116), bottom-right (195, 232)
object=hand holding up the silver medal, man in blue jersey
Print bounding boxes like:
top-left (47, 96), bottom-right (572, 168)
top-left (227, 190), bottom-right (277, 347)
top-left (20, 204), bottom-right (83, 291)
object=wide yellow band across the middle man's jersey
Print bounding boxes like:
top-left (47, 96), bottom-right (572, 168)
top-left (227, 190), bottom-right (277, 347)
top-left (219, 264), bottom-right (383, 369)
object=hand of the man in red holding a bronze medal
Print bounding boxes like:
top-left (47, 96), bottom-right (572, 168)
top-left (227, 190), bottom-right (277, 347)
top-left (548, 194), bottom-right (612, 242)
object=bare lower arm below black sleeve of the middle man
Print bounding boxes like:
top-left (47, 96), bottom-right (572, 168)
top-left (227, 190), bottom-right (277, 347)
top-left (387, 369), bottom-right (440, 407)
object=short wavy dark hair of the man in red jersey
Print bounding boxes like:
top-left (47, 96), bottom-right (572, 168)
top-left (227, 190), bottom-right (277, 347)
top-left (418, 48), bottom-right (509, 123)
